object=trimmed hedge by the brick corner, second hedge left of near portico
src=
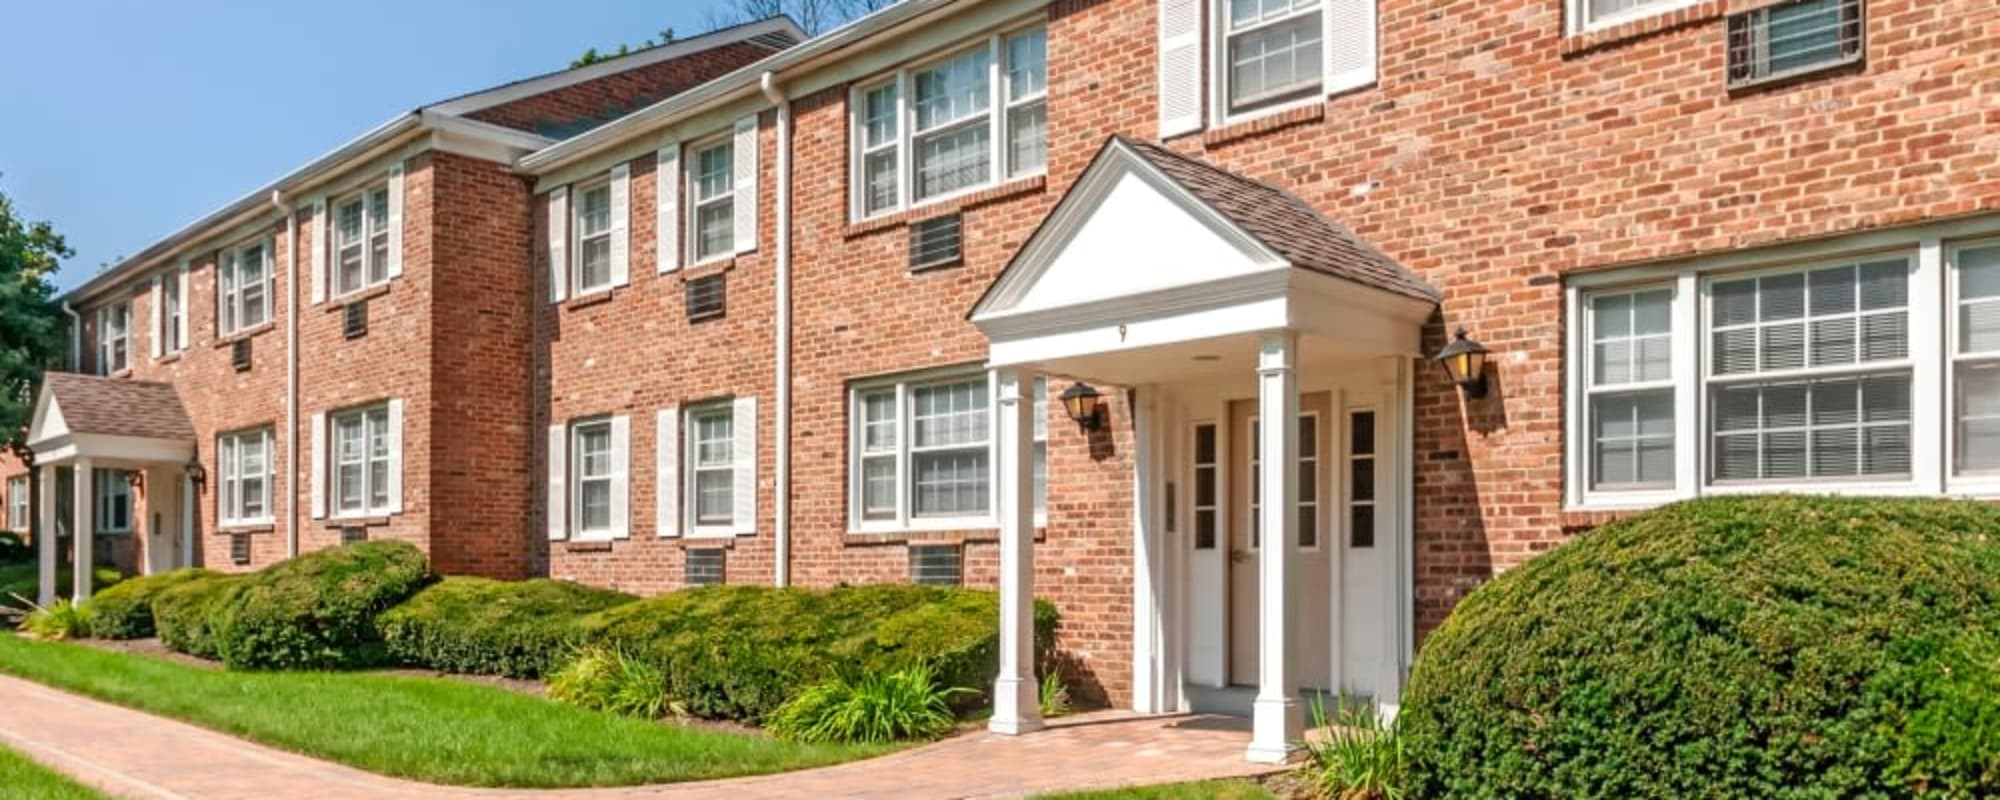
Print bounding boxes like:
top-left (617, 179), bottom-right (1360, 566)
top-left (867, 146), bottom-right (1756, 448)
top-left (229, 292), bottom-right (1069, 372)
top-left (376, 578), bottom-right (638, 678)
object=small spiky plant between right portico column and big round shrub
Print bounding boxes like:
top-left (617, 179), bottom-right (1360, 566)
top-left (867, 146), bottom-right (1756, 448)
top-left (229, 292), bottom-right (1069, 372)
top-left (1306, 696), bottom-right (1408, 800)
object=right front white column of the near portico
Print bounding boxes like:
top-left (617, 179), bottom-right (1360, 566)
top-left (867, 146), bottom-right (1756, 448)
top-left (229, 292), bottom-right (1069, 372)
top-left (1248, 332), bottom-right (1306, 764)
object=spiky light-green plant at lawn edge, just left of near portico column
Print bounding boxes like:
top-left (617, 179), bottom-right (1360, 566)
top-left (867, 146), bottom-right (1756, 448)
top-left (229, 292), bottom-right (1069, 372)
top-left (764, 664), bottom-right (972, 744)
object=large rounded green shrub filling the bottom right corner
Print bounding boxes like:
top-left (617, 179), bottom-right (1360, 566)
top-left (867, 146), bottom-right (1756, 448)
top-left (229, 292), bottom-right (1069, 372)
top-left (1398, 496), bottom-right (2000, 798)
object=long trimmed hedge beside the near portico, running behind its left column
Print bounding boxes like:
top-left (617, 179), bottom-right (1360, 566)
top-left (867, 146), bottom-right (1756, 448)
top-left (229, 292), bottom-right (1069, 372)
top-left (582, 584), bottom-right (1056, 722)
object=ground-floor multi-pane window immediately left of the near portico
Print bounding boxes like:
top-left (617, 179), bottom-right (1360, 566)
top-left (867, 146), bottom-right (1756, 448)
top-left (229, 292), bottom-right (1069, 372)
top-left (852, 374), bottom-right (1048, 530)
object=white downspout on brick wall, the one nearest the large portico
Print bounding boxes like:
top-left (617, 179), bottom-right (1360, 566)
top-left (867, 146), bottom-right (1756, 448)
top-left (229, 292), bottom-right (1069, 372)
top-left (758, 72), bottom-right (792, 588)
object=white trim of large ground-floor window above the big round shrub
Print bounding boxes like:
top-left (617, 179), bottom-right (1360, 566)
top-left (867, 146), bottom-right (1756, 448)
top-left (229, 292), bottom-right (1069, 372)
top-left (1564, 238), bottom-right (1952, 512)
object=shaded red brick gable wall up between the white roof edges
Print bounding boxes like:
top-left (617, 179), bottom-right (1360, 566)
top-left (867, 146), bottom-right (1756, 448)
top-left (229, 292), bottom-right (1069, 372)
top-left (466, 42), bottom-right (772, 138)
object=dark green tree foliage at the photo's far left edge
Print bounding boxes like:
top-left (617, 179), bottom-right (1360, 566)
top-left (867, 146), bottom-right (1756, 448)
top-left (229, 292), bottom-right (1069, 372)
top-left (0, 179), bottom-right (74, 456)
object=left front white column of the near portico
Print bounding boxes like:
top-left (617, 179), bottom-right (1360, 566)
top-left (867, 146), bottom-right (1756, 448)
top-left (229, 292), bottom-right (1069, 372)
top-left (986, 368), bottom-right (1042, 736)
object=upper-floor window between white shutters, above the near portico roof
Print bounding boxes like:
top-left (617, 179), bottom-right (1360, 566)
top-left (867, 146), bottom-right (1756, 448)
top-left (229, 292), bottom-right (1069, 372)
top-left (1222, 0), bottom-right (1326, 114)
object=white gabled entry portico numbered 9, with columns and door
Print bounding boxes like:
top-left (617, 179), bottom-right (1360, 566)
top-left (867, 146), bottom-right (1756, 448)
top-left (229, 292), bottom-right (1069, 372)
top-left (972, 138), bottom-right (1438, 762)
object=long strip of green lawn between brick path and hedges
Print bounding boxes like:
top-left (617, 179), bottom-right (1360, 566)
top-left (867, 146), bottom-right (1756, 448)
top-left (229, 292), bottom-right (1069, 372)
top-left (0, 636), bottom-right (892, 788)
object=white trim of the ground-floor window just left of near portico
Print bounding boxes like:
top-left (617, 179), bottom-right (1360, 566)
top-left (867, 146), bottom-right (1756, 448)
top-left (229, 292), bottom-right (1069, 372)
top-left (848, 368), bottom-right (1056, 534)
